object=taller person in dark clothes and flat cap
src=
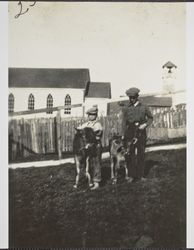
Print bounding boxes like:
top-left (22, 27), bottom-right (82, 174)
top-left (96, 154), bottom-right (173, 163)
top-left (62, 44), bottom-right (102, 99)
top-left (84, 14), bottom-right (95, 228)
top-left (122, 88), bottom-right (153, 181)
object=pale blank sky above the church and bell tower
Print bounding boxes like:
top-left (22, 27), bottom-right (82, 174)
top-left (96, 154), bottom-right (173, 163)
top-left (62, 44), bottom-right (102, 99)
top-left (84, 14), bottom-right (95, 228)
top-left (9, 2), bottom-right (186, 97)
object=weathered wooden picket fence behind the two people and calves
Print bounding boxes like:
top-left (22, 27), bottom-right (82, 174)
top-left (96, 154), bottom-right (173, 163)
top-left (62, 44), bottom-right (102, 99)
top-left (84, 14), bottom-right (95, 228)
top-left (9, 109), bottom-right (186, 160)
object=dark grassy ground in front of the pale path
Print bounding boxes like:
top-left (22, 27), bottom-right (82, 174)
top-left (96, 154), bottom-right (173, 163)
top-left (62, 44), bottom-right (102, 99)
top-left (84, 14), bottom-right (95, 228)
top-left (9, 149), bottom-right (186, 248)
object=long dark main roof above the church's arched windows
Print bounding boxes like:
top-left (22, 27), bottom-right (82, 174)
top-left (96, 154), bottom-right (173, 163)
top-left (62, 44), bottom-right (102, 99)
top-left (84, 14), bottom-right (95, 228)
top-left (9, 68), bottom-right (90, 89)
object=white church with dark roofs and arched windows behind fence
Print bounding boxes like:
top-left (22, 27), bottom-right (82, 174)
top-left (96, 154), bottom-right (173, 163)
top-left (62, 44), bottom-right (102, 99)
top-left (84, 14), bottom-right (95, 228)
top-left (8, 68), bottom-right (111, 117)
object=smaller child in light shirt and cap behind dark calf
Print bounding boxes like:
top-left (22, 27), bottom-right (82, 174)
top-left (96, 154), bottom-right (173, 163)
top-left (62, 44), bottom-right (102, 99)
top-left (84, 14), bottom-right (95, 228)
top-left (78, 106), bottom-right (103, 190)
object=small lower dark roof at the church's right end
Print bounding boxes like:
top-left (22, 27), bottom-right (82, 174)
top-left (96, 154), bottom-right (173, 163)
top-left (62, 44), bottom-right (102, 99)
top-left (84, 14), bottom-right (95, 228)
top-left (85, 82), bottom-right (111, 99)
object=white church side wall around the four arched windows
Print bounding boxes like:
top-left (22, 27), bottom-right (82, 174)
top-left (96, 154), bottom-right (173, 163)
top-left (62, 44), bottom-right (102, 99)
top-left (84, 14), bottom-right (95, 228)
top-left (9, 88), bottom-right (84, 117)
